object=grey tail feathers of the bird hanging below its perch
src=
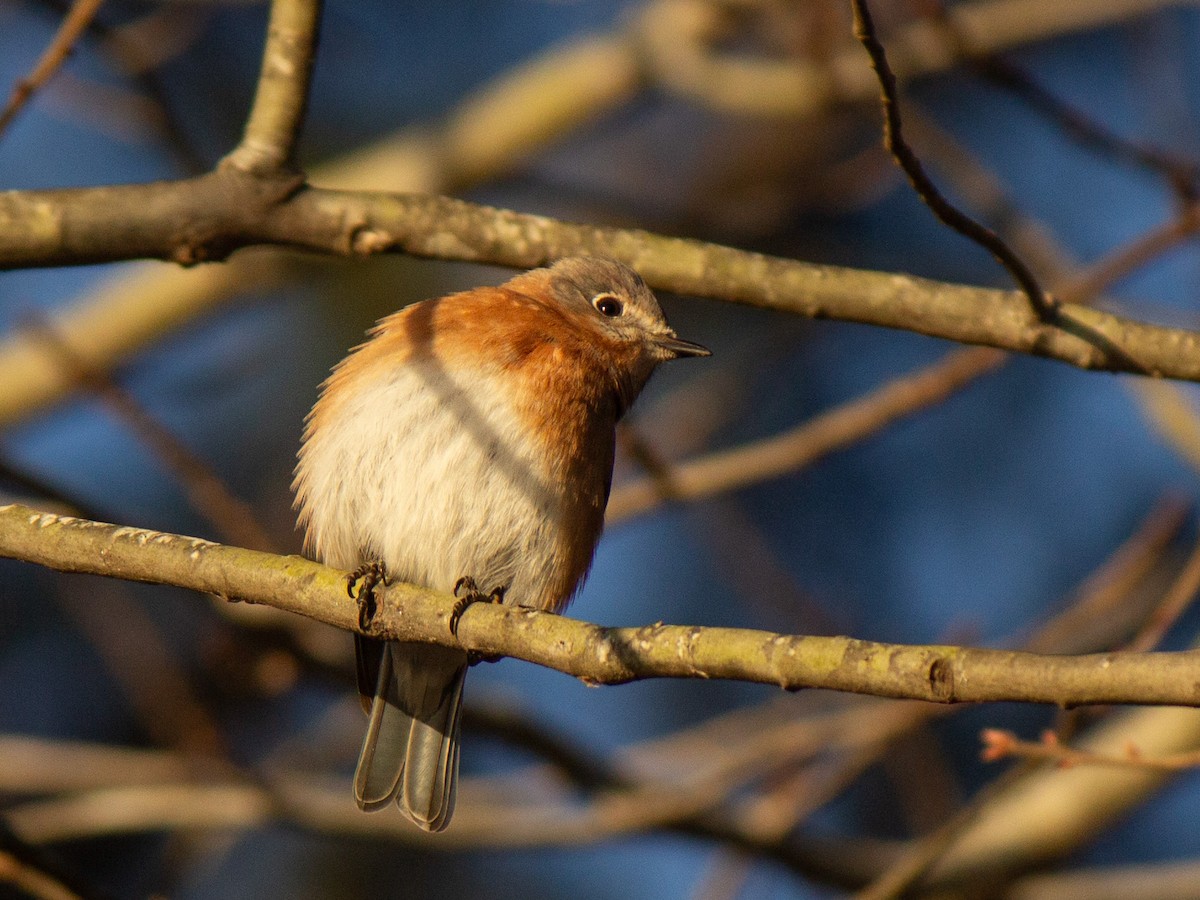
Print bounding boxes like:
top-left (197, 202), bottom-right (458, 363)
top-left (354, 642), bottom-right (467, 832)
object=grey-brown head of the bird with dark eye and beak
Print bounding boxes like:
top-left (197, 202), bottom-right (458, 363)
top-left (548, 257), bottom-right (710, 367)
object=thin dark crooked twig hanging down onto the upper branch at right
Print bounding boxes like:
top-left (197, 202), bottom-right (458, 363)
top-left (851, 0), bottom-right (1058, 323)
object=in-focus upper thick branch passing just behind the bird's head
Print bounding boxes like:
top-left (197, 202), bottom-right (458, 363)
top-left (0, 181), bottom-right (1200, 380)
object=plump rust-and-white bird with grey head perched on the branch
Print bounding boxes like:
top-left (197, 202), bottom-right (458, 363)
top-left (293, 256), bottom-right (710, 832)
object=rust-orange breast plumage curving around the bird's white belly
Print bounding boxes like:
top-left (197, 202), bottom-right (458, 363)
top-left (308, 278), bottom-right (620, 610)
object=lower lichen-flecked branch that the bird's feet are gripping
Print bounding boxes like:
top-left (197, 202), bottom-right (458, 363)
top-left (7, 505), bottom-right (1200, 706)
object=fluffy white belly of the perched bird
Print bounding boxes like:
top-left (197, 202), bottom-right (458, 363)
top-left (296, 360), bottom-right (563, 605)
